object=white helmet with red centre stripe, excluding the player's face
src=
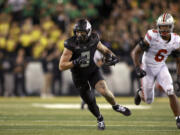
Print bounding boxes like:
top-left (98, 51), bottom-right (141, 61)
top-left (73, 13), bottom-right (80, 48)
top-left (156, 13), bottom-right (174, 34)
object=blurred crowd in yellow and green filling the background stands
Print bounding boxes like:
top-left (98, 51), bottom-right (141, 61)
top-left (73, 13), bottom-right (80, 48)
top-left (0, 0), bottom-right (180, 96)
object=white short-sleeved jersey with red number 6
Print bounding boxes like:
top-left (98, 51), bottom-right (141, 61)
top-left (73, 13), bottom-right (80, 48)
top-left (142, 30), bottom-right (180, 66)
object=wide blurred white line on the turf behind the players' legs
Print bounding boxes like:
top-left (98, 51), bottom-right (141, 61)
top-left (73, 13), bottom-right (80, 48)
top-left (32, 103), bottom-right (151, 109)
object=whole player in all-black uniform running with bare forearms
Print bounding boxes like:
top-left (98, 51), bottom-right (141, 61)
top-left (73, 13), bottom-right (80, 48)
top-left (59, 19), bottom-right (131, 130)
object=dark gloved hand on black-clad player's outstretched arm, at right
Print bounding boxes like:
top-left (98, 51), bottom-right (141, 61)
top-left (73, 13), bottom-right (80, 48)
top-left (103, 54), bottom-right (120, 66)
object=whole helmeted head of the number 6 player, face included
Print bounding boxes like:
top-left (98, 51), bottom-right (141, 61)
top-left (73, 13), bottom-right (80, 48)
top-left (156, 13), bottom-right (174, 37)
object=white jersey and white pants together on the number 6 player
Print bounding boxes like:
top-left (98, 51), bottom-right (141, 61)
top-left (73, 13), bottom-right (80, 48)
top-left (141, 30), bottom-right (180, 104)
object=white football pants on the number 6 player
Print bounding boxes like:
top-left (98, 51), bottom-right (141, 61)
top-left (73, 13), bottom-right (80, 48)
top-left (141, 64), bottom-right (174, 104)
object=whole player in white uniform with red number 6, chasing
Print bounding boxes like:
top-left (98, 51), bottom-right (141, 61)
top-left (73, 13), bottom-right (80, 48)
top-left (131, 13), bottom-right (180, 129)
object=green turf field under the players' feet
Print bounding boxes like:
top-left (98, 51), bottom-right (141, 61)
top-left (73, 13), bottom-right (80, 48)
top-left (0, 97), bottom-right (180, 135)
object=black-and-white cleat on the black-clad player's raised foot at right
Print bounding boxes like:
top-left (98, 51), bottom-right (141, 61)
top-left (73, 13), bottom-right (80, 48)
top-left (112, 105), bottom-right (131, 116)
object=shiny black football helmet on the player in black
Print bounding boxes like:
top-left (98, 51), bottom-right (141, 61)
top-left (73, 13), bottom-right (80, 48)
top-left (73, 19), bottom-right (92, 42)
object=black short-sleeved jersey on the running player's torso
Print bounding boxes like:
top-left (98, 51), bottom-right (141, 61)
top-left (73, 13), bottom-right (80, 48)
top-left (64, 33), bottom-right (99, 77)
